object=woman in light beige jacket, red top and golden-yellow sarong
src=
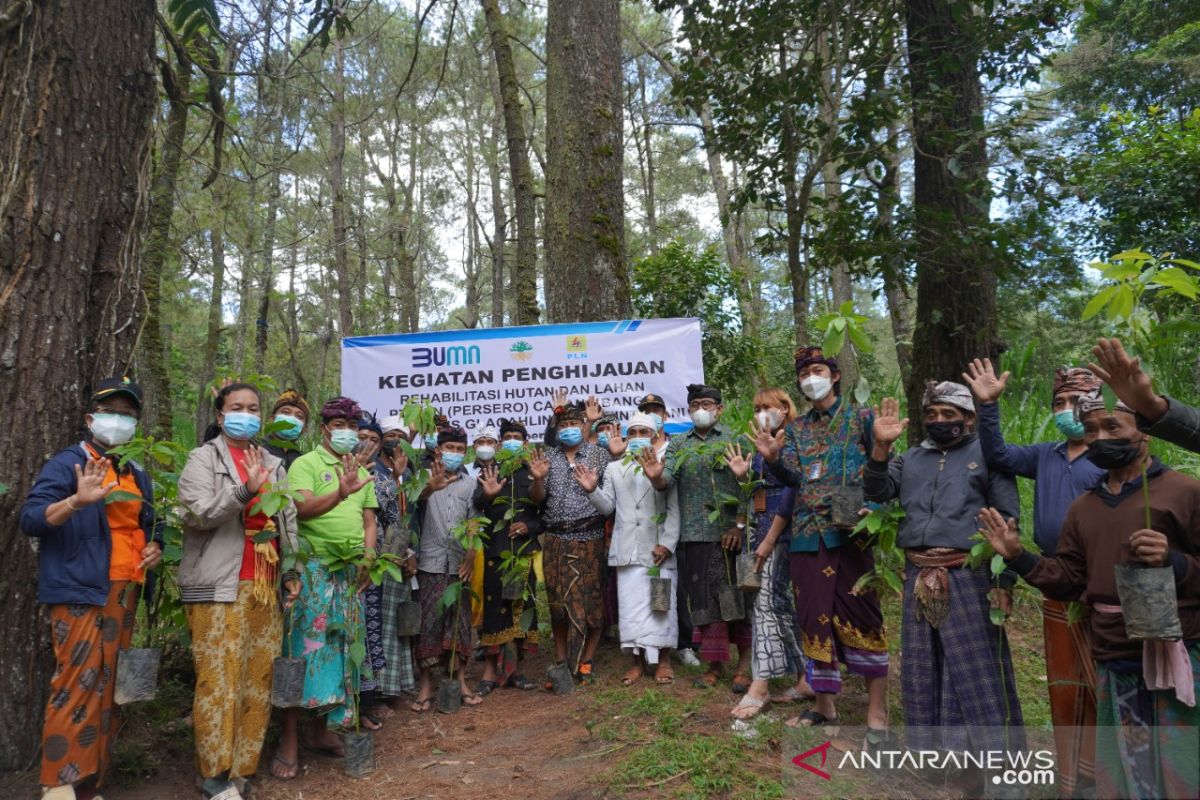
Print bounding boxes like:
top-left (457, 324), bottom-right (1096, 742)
top-left (179, 383), bottom-right (300, 800)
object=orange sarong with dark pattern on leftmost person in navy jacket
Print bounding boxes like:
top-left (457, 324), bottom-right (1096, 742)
top-left (41, 581), bottom-right (138, 787)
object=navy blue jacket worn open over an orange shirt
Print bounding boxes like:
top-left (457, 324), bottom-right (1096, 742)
top-left (20, 443), bottom-right (163, 606)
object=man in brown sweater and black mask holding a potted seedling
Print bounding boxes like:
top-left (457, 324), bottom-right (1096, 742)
top-left (980, 391), bottom-right (1200, 798)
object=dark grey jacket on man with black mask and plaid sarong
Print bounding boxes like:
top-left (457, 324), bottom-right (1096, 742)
top-left (863, 434), bottom-right (1021, 551)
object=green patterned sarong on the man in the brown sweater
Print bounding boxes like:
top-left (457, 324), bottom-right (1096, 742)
top-left (1096, 642), bottom-right (1200, 799)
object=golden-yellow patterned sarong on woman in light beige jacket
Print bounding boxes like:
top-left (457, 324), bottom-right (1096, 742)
top-left (184, 581), bottom-right (283, 778)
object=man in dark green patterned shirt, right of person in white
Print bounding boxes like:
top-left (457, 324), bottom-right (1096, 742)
top-left (647, 384), bottom-right (751, 694)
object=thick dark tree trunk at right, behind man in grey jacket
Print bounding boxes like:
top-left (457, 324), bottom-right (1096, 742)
top-left (905, 0), bottom-right (1000, 443)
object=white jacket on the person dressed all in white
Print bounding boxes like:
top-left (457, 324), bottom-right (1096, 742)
top-left (588, 461), bottom-right (679, 566)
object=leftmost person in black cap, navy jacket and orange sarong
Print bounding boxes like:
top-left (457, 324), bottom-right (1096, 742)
top-left (20, 378), bottom-right (162, 800)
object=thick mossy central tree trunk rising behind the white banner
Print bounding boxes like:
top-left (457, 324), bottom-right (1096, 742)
top-left (546, 0), bottom-right (631, 321)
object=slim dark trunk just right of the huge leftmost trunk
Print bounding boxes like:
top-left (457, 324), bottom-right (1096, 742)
top-left (138, 46), bottom-right (192, 439)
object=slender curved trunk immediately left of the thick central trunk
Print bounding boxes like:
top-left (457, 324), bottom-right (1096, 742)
top-left (482, 0), bottom-right (540, 325)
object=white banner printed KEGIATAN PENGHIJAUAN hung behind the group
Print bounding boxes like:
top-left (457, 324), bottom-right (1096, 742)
top-left (342, 319), bottom-right (704, 440)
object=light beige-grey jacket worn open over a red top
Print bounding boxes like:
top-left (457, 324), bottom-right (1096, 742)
top-left (179, 437), bottom-right (300, 603)
